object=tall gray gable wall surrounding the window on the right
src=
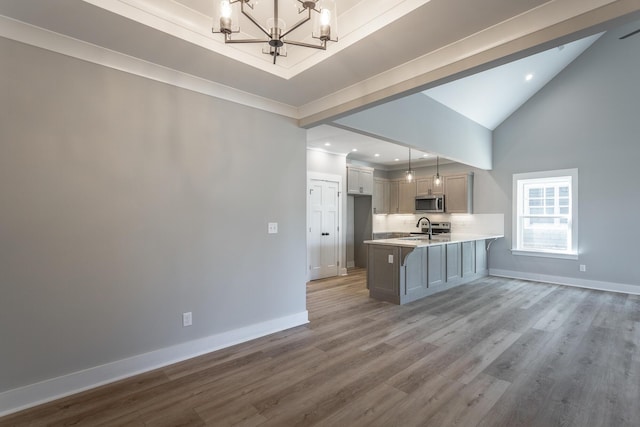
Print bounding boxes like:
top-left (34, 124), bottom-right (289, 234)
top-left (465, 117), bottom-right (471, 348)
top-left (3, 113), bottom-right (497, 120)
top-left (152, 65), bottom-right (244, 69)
top-left (484, 23), bottom-right (640, 286)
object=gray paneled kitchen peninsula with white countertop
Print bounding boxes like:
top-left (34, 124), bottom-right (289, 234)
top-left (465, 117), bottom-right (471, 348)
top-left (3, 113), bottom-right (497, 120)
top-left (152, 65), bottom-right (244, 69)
top-left (364, 233), bottom-right (504, 304)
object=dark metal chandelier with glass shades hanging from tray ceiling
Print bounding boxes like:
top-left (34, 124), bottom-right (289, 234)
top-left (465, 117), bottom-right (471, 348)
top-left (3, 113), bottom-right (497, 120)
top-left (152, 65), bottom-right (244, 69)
top-left (212, 0), bottom-right (338, 64)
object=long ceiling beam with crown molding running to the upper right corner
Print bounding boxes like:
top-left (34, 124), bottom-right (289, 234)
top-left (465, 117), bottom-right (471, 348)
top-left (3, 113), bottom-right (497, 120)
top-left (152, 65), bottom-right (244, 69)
top-left (299, 0), bottom-right (640, 128)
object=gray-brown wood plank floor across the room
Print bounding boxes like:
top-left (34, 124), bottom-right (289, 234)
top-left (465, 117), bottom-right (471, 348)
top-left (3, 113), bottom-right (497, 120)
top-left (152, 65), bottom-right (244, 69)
top-left (0, 270), bottom-right (640, 427)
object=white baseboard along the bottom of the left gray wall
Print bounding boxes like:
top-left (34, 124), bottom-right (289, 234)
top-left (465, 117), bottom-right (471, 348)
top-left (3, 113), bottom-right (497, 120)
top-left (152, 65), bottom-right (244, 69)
top-left (0, 310), bottom-right (309, 417)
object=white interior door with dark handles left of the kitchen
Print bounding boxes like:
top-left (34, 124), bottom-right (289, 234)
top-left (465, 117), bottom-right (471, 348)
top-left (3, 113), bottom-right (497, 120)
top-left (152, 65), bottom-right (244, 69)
top-left (307, 179), bottom-right (340, 280)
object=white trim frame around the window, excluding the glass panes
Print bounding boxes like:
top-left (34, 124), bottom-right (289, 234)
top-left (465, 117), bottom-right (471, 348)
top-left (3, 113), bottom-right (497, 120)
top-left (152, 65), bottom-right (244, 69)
top-left (511, 168), bottom-right (579, 260)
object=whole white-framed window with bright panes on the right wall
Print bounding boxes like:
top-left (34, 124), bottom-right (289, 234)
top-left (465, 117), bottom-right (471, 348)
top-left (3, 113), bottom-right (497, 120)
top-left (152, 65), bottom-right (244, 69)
top-left (512, 169), bottom-right (578, 259)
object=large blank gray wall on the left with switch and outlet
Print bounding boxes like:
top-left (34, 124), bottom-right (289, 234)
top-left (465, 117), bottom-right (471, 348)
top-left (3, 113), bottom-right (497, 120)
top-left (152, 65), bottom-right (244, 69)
top-left (0, 38), bottom-right (306, 392)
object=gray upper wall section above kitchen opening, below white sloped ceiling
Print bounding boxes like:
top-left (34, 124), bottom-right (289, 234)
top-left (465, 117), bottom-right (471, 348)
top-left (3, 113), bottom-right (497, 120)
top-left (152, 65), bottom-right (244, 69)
top-left (336, 93), bottom-right (492, 169)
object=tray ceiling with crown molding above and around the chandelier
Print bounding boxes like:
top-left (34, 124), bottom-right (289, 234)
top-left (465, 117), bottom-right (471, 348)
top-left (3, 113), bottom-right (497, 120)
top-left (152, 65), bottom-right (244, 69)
top-left (0, 0), bottom-right (640, 127)
